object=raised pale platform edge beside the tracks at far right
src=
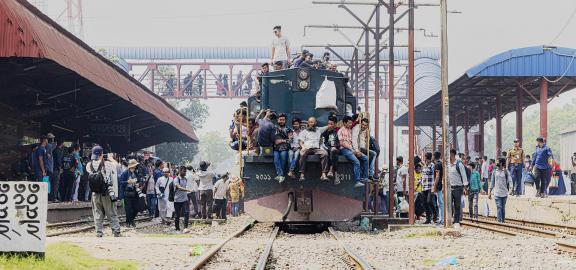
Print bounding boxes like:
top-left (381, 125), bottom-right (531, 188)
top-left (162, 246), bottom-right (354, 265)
top-left (463, 195), bottom-right (576, 225)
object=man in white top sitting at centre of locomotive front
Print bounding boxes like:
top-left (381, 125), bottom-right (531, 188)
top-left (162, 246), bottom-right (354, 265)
top-left (299, 117), bottom-right (328, 181)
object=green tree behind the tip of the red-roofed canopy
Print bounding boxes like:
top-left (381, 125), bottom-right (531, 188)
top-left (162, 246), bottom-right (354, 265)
top-left (156, 99), bottom-right (209, 164)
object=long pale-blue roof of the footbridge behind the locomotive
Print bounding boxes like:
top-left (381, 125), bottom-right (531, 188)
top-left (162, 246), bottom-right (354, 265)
top-left (102, 47), bottom-right (439, 61)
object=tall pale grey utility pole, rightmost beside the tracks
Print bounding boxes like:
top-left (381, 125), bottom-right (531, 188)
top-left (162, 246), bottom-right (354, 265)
top-left (440, 0), bottom-right (452, 228)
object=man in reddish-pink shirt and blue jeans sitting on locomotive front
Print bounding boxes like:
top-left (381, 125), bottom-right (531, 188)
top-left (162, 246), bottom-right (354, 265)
top-left (338, 116), bottom-right (368, 187)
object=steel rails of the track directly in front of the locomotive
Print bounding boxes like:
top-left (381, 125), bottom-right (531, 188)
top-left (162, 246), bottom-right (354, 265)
top-left (192, 222), bottom-right (373, 270)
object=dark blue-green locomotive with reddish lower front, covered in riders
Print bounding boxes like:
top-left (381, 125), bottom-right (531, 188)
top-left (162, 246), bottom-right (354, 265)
top-left (241, 68), bottom-right (364, 223)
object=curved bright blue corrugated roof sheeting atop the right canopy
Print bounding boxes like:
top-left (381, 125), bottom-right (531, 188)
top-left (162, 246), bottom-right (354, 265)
top-left (466, 46), bottom-right (576, 77)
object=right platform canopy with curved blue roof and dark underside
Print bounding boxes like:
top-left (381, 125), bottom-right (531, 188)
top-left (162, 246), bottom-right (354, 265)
top-left (394, 46), bottom-right (576, 126)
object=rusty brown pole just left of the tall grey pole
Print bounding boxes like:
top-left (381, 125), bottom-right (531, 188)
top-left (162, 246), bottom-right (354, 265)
top-left (408, 0), bottom-right (416, 225)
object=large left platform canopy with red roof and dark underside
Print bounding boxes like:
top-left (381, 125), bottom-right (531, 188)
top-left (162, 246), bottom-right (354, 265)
top-left (0, 0), bottom-right (198, 152)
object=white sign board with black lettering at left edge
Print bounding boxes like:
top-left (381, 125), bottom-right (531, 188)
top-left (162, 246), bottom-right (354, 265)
top-left (0, 181), bottom-right (48, 253)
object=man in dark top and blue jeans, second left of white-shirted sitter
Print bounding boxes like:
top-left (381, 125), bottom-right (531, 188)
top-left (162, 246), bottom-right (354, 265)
top-left (274, 113), bottom-right (292, 183)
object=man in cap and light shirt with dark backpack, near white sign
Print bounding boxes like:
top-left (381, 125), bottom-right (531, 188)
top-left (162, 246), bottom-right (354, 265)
top-left (86, 146), bottom-right (120, 237)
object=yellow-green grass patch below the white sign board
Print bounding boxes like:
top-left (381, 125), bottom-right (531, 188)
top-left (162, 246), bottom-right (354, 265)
top-left (0, 243), bottom-right (138, 270)
